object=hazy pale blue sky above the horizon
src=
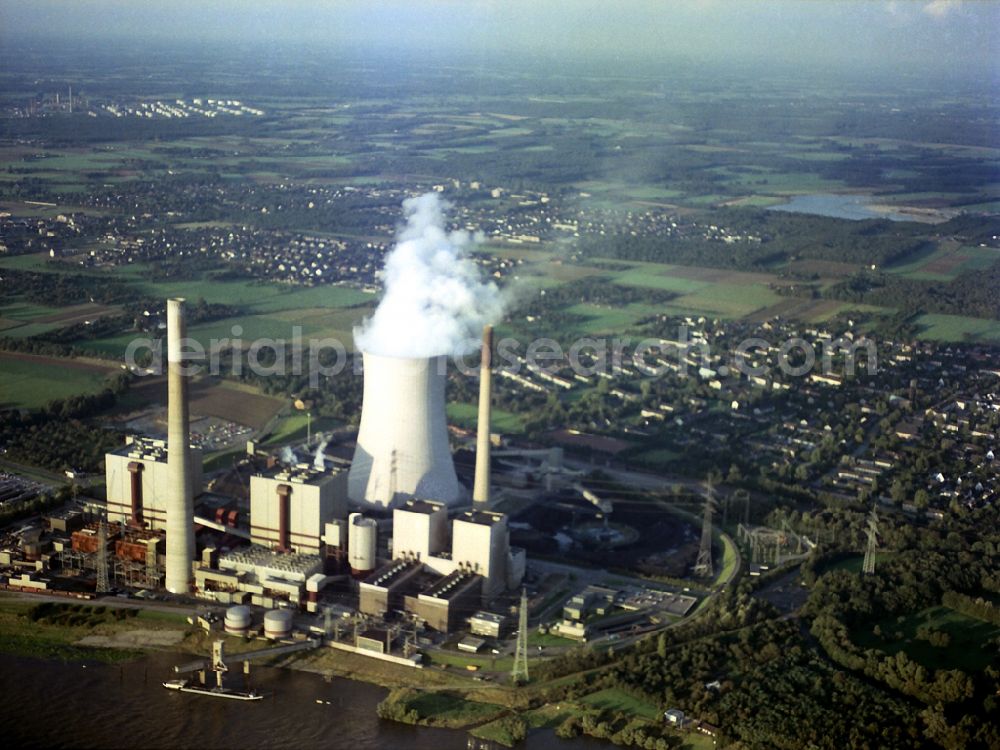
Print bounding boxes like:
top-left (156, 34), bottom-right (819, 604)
top-left (0, 0), bottom-right (1000, 82)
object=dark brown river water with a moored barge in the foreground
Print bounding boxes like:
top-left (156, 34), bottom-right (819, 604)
top-left (0, 653), bottom-right (611, 750)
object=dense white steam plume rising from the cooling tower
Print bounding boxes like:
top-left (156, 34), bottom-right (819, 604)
top-left (354, 193), bottom-right (504, 357)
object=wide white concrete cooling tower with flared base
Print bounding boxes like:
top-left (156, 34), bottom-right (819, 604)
top-left (347, 352), bottom-right (462, 509)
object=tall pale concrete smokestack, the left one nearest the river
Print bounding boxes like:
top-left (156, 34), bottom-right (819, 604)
top-left (165, 299), bottom-right (194, 594)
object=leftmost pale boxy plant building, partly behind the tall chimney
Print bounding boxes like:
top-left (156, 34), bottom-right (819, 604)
top-left (104, 437), bottom-right (202, 530)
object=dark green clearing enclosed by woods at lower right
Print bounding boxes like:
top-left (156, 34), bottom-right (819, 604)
top-left (852, 607), bottom-right (1000, 671)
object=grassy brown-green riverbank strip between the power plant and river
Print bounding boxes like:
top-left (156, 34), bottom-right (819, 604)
top-left (0, 595), bottom-right (684, 746)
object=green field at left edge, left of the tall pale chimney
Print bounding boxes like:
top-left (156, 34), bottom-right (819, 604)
top-left (0, 355), bottom-right (116, 409)
